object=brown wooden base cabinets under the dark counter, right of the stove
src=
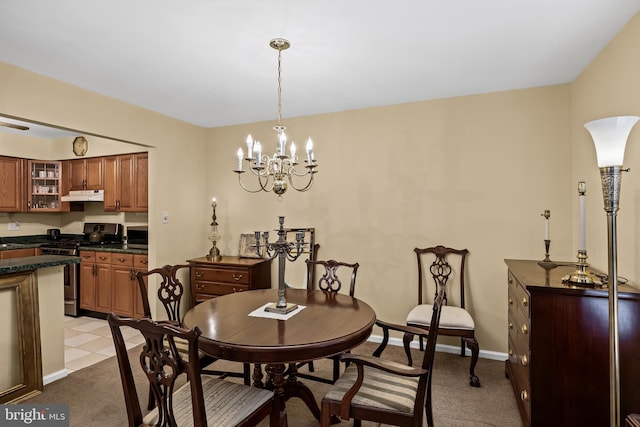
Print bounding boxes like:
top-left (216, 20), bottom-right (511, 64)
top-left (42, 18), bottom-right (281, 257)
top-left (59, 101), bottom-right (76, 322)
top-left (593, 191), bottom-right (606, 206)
top-left (80, 251), bottom-right (148, 317)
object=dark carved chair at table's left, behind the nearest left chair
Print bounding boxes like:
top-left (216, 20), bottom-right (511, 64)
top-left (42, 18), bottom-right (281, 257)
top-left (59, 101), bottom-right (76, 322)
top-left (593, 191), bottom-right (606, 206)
top-left (136, 264), bottom-right (251, 402)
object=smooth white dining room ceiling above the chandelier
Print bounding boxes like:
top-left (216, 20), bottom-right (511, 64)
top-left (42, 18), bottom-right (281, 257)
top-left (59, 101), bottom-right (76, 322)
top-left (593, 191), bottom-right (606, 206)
top-left (0, 0), bottom-right (640, 127)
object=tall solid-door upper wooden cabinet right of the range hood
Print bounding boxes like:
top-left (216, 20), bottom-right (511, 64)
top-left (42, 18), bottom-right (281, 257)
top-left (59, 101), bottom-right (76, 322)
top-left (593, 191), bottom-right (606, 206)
top-left (103, 153), bottom-right (149, 212)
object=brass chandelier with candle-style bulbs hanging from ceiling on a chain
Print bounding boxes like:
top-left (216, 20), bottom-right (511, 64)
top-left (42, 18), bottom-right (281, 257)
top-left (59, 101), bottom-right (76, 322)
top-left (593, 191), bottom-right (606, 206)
top-left (234, 39), bottom-right (318, 199)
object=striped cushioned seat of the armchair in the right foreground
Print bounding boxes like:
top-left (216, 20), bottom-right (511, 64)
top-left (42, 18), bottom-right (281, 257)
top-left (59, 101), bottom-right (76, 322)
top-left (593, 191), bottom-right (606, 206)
top-left (324, 361), bottom-right (419, 415)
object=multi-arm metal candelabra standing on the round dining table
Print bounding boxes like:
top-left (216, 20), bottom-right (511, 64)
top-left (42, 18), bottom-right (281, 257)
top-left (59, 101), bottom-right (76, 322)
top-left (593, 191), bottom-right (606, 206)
top-left (255, 216), bottom-right (308, 314)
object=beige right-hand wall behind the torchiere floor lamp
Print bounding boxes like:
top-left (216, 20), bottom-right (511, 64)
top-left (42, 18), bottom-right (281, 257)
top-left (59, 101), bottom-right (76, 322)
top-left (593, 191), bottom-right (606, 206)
top-left (571, 10), bottom-right (640, 285)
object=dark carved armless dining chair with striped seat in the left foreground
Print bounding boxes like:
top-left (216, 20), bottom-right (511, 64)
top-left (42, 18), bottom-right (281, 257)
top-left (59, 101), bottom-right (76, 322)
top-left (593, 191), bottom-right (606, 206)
top-left (107, 313), bottom-right (275, 427)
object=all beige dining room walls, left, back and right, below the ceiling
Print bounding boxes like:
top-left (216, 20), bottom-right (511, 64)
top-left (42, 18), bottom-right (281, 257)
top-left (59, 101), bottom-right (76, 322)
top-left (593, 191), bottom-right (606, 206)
top-left (0, 12), bottom-right (640, 352)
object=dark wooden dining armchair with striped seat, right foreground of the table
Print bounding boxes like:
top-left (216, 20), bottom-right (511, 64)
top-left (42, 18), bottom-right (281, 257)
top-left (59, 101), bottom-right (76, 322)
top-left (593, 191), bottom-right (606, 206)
top-left (321, 293), bottom-right (443, 427)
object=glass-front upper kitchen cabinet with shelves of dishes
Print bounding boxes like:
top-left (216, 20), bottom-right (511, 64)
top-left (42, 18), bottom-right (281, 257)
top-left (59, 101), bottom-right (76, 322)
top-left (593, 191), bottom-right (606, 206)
top-left (27, 160), bottom-right (68, 212)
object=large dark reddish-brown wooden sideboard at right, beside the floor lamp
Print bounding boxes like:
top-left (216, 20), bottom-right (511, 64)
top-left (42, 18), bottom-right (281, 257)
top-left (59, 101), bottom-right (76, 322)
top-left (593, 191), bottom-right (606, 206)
top-left (505, 259), bottom-right (640, 427)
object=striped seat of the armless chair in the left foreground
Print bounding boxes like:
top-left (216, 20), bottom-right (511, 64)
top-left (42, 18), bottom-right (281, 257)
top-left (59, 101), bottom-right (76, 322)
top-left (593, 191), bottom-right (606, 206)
top-left (143, 375), bottom-right (273, 427)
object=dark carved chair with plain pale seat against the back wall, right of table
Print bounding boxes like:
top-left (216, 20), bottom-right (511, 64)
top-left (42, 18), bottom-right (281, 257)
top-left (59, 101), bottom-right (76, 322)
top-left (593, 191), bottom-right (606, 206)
top-left (405, 245), bottom-right (480, 387)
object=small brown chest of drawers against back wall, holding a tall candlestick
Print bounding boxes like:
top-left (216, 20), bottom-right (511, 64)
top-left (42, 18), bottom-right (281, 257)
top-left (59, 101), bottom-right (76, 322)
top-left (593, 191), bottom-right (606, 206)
top-left (187, 256), bottom-right (271, 306)
